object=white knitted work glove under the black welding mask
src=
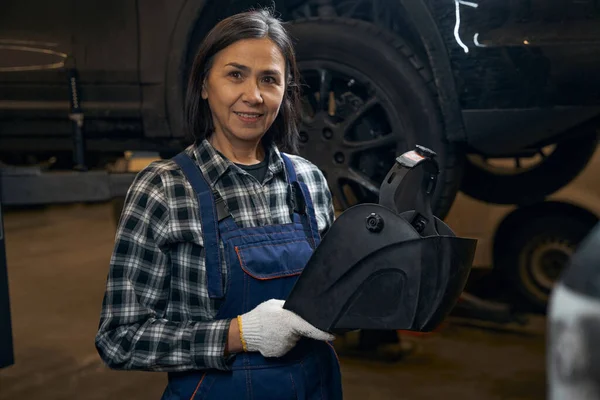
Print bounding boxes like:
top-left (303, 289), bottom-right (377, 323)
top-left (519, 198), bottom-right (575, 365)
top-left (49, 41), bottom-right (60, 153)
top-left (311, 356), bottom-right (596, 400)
top-left (238, 299), bottom-right (335, 357)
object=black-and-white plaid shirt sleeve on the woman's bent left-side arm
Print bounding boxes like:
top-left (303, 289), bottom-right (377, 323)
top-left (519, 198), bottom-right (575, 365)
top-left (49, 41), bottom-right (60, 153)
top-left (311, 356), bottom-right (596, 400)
top-left (95, 166), bottom-right (232, 371)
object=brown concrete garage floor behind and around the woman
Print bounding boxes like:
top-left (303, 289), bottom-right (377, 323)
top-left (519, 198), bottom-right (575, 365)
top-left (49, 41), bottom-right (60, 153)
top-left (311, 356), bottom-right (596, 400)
top-left (0, 204), bottom-right (545, 400)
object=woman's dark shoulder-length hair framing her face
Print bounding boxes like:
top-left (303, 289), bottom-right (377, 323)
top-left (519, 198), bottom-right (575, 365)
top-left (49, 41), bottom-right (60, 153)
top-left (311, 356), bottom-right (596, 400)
top-left (185, 9), bottom-right (300, 153)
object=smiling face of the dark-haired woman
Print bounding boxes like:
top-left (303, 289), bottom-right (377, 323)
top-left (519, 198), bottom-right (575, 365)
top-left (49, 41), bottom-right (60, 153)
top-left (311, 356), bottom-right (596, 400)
top-left (202, 38), bottom-right (285, 143)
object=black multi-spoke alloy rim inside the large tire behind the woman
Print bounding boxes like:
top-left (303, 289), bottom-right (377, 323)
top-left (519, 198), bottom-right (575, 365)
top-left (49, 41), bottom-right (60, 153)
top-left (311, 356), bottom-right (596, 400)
top-left (299, 61), bottom-right (402, 210)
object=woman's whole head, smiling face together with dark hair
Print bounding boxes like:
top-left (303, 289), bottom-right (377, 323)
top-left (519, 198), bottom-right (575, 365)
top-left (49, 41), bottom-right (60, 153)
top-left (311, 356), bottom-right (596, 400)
top-left (185, 11), bottom-right (300, 159)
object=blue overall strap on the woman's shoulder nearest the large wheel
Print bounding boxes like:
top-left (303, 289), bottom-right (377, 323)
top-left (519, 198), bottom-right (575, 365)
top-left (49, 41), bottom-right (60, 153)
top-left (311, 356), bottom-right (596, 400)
top-left (281, 153), bottom-right (321, 249)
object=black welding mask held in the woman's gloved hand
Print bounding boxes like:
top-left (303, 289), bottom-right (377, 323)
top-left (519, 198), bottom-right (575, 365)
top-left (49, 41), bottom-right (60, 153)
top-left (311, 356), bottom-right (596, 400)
top-left (284, 146), bottom-right (477, 333)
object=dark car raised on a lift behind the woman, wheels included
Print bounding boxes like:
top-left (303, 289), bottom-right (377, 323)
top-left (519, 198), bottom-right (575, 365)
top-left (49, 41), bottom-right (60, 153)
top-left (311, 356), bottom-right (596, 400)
top-left (0, 0), bottom-right (600, 217)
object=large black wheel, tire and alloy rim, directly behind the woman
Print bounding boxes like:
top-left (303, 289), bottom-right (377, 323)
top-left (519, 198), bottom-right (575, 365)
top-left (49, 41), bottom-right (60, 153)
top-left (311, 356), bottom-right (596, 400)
top-left (289, 18), bottom-right (462, 218)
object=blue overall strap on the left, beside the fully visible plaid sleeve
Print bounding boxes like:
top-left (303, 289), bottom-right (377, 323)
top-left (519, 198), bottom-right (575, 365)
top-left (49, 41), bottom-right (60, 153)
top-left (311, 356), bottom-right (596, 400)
top-left (173, 152), bottom-right (223, 298)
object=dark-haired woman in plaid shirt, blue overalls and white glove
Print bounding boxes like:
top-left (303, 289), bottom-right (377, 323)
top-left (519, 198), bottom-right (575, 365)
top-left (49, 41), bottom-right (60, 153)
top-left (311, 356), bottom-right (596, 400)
top-left (96, 7), bottom-right (342, 399)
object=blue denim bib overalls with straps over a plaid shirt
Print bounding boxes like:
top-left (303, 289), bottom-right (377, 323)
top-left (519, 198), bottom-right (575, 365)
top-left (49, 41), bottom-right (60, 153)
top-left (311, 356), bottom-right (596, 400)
top-left (163, 153), bottom-right (342, 400)
